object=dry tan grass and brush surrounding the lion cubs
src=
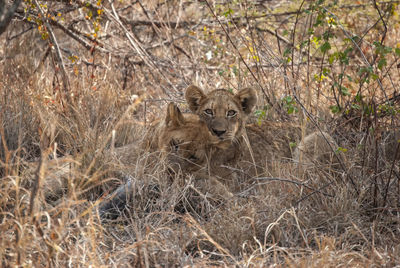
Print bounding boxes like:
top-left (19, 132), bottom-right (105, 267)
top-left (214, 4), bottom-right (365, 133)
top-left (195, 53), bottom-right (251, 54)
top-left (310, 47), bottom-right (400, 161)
top-left (0, 1), bottom-right (400, 267)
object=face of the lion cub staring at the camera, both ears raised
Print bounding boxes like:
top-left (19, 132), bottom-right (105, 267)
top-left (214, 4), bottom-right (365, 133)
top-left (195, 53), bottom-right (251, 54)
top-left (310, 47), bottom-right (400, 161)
top-left (185, 85), bottom-right (257, 141)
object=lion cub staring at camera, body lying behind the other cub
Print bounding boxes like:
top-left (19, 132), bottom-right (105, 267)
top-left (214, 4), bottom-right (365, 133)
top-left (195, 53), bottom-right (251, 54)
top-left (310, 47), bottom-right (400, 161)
top-left (185, 85), bottom-right (344, 187)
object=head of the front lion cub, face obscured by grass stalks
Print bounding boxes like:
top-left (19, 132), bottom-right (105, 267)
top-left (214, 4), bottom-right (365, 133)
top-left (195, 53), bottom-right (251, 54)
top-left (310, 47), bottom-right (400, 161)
top-left (158, 103), bottom-right (223, 172)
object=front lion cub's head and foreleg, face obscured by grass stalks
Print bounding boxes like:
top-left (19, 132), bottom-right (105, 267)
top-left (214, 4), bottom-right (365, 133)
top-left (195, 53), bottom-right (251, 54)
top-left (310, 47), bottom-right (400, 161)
top-left (158, 103), bottom-right (232, 199)
